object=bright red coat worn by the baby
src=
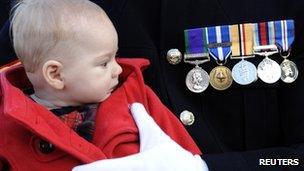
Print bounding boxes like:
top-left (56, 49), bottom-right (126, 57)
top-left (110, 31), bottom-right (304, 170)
top-left (0, 59), bottom-right (200, 171)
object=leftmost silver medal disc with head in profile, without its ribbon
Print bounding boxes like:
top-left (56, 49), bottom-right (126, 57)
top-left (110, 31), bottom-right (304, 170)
top-left (186, 66), bottom-right (210, 93)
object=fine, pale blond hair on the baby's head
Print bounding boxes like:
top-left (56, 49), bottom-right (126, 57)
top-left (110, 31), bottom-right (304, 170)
top-left (10, 0), bottom-right (107, 72)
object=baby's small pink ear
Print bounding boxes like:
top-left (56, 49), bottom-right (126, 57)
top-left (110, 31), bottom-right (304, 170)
top-left (42, 60), bottom-right (64, 90)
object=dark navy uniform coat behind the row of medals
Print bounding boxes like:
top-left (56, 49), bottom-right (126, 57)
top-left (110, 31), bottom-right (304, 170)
top-left (0, 0), bottom-right (304, 171)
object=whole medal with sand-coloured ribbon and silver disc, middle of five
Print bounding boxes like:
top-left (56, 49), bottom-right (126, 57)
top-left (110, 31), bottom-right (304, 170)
top-left (230, 23), bottom-right (257, 85)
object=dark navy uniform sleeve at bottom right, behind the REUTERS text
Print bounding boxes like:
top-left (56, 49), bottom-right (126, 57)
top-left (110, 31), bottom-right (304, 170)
top-left (202, 144), bottom-right (304, 171)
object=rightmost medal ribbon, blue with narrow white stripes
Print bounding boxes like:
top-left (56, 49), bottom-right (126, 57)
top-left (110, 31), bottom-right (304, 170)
top-left (274, 20), bottom-right (294, 52)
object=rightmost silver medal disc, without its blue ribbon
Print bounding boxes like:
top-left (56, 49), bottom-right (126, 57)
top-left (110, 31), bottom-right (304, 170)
top-left (280, 59), bottom-right (299, 83)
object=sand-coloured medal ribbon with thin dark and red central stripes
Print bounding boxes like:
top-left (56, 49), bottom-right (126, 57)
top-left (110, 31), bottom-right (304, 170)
top-left (230, 23), bottom-right (253, 58)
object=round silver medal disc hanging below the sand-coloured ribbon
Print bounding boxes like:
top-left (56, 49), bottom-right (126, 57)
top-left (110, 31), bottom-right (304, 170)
top-left (232, 59), bottom-right (257, 85)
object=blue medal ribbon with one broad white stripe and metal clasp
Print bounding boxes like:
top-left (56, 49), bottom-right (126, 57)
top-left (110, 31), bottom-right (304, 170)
top-left (206, 25), bottom-right (231, 62)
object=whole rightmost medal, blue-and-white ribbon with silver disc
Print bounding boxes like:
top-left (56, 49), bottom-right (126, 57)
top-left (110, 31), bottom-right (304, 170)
top-left (274, 20), bottom-right (299, 83)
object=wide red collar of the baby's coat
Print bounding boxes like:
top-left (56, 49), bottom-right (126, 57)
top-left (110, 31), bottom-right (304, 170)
top-left (0, 58), bottom-right (149, 163)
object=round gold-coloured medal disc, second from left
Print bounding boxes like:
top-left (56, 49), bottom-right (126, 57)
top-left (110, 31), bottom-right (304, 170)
top-left (209, 66), bottom-right (233, 90)
